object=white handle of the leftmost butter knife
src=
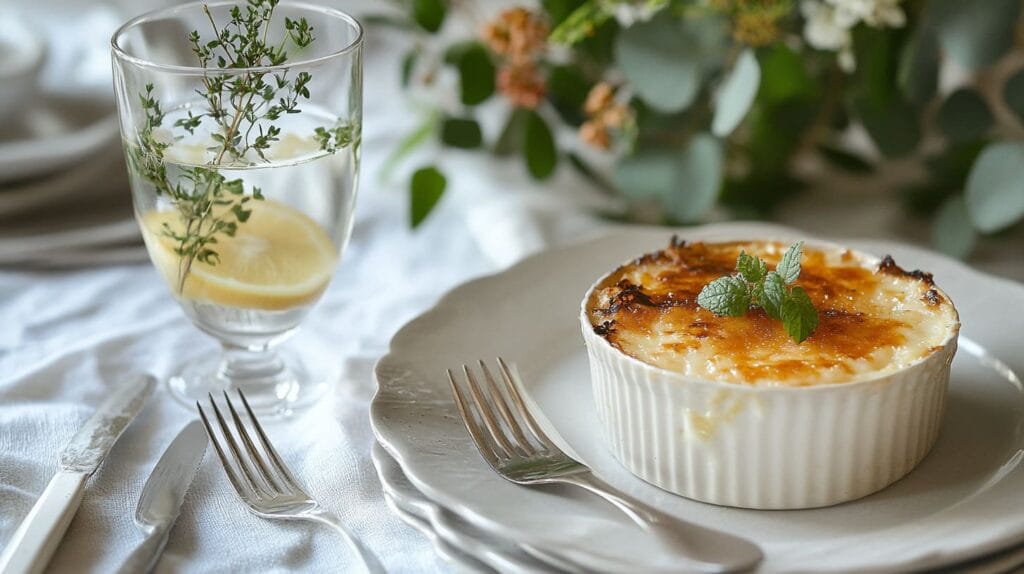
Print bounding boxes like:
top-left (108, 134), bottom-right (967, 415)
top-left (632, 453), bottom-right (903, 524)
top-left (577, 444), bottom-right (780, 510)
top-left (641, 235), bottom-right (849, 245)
top-left (0, 471), bottom-right (89, 574)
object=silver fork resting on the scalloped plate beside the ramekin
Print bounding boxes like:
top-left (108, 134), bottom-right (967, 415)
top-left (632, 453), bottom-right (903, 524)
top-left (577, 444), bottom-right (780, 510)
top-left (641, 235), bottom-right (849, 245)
top-left (447, 357), bottom-right (764, 572)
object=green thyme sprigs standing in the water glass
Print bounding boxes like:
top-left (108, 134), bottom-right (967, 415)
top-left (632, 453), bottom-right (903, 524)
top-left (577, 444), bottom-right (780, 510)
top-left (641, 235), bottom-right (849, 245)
top-left (128, 0), bottom-right (359, 293)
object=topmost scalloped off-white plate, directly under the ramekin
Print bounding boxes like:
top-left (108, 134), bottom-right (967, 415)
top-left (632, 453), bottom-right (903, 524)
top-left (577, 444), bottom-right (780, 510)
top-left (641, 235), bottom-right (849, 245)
top-left (371, 224), bottom-right (1024, 572)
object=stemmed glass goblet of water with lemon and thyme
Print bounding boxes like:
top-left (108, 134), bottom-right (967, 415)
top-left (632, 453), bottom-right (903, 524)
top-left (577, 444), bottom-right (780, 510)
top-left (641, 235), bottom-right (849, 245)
top-left (112, 0), bottom-right (362, 413)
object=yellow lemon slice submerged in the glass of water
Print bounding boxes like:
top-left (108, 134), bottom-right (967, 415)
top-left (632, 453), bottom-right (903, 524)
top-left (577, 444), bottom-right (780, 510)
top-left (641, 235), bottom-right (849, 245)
top-left (141, 200), bottom-right (338, 310)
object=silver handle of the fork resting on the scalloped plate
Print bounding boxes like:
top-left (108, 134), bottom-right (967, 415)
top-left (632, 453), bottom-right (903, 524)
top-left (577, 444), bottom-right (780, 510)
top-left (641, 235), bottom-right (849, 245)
top-left (561, 473), bottom-right (764, 572)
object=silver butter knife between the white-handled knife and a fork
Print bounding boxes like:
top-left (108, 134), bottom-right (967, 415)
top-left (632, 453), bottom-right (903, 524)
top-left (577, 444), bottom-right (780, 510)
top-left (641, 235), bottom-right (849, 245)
top-left (119, 421), bottom-right (208, 574)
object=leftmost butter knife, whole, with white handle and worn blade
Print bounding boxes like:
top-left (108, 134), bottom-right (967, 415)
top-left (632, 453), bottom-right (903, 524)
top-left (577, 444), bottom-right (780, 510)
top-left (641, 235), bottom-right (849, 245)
top-left (0, 376), bottom-right (157, 574)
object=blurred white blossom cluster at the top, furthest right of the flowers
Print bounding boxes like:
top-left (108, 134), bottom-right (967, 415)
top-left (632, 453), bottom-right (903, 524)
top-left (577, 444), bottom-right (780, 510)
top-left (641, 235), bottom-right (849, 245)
top-left (800, 0), bottom-right (906, 72)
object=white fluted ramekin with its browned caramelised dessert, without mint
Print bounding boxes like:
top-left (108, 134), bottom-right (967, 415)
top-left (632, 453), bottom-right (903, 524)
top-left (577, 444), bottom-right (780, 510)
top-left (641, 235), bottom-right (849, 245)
top-left (581, 238), bottom-right (959, 509)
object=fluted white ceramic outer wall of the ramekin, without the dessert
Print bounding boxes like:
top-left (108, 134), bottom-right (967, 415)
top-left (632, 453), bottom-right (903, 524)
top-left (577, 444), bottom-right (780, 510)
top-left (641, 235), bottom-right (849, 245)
top-left (581, 252), bottom-right (956, 510)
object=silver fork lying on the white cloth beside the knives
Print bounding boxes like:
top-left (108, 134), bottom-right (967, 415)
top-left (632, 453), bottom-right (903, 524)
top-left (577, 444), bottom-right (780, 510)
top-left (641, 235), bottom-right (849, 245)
top-left (196, 390), bottom-right (384, 574)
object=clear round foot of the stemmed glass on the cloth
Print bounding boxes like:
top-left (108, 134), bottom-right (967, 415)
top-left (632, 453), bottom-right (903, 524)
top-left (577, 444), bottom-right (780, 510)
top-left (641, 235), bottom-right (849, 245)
top-left (168, 349), bottom-right (328, 418)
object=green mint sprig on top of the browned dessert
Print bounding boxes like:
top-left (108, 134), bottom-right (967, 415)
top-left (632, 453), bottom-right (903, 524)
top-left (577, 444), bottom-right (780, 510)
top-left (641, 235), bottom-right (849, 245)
top-left (697, 241), bottom-right (818, 343)
